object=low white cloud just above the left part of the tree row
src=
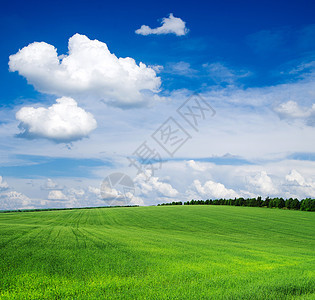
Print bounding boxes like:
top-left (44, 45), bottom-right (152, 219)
top-left (193, 179), bottom-right (238, 199)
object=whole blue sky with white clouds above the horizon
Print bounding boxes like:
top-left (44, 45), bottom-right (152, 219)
top-left (0, 0), bottom-right (315, 210)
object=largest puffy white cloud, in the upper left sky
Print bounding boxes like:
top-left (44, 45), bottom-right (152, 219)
top-left (9, 34), bottom-right (161, 106)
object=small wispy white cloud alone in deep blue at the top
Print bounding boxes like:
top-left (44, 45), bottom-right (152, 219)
top-left (135, 13), bottom-right (189, 36)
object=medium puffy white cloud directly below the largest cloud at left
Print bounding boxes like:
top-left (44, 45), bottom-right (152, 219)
top-left (16, 97), bottom-right (97, 142)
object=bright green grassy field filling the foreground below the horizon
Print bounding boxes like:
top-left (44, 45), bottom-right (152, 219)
top-left (0, 206), bottom-right (315, 299)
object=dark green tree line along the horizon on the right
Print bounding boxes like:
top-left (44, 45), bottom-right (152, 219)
top-left (158, 197), bottom-right (315, 211)
